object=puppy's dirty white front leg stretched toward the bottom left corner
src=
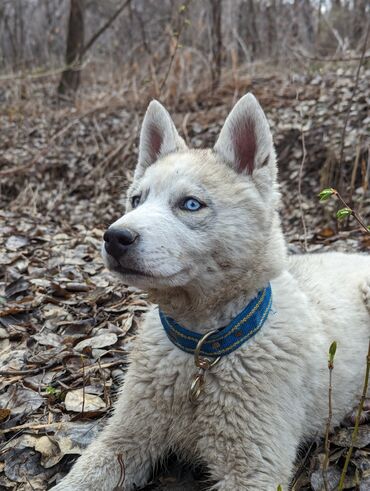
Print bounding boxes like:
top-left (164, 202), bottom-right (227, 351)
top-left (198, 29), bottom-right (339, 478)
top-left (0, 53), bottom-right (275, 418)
top-left (52, 373), bottom-right (166, 491)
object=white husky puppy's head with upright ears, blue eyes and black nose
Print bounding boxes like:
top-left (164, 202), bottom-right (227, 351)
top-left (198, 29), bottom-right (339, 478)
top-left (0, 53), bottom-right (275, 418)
top-left (103, 94), bottom-right (284, 291)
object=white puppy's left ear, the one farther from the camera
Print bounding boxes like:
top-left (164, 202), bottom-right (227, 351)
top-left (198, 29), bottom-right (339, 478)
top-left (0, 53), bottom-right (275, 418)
top-left (135, 100), bottom-right (187, 177)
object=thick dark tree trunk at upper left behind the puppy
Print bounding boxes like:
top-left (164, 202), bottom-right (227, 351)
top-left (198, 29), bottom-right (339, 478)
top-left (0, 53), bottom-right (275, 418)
top-left (58, 0), bottom-right (84, 95)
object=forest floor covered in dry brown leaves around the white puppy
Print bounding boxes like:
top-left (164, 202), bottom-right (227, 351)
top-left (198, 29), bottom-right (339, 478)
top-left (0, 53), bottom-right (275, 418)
top-left (0, 63), bottom-right (370, 491)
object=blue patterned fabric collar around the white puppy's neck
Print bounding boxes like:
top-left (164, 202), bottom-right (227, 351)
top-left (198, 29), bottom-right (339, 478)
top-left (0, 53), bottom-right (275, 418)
top-left (159, 284), bottom-right (272, 357)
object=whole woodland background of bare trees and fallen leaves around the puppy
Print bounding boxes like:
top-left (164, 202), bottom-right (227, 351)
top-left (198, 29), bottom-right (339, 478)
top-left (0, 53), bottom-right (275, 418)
top-left (0, 0), bottom-right (370, 491)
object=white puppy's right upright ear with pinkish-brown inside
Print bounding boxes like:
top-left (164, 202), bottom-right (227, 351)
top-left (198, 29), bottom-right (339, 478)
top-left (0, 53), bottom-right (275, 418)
top-left (214, 93), bottom-right (274, 174)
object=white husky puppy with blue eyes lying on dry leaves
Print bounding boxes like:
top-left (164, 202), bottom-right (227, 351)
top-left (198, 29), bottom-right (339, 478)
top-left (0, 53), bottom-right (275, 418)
top-left (53, 94), bottom-right (370, 491)
